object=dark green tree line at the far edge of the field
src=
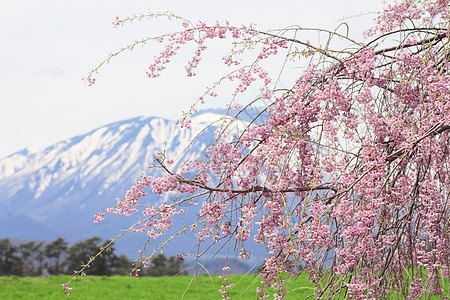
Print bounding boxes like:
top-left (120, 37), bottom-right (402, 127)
top-left (0, 236), bottom-right (185, 276)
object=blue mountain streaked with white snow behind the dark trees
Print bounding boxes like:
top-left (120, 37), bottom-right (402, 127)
top-left (0, 112), bottom-right (225, 252)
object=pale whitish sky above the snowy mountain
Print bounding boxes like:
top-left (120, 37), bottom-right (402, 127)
top-left (0, 0), bottom-right (382, 159)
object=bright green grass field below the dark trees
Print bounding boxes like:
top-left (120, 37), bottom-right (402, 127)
top-left (0, 275), bottom-right (311, 300)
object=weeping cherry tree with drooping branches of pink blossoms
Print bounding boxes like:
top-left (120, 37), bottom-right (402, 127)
top-left (65, 0), bottom-right (450, 299)
